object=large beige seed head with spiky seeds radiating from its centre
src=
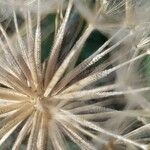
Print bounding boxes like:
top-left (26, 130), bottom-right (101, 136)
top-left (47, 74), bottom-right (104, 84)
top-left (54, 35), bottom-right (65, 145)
top-left (0, 0), bottom-right (150, 150)
